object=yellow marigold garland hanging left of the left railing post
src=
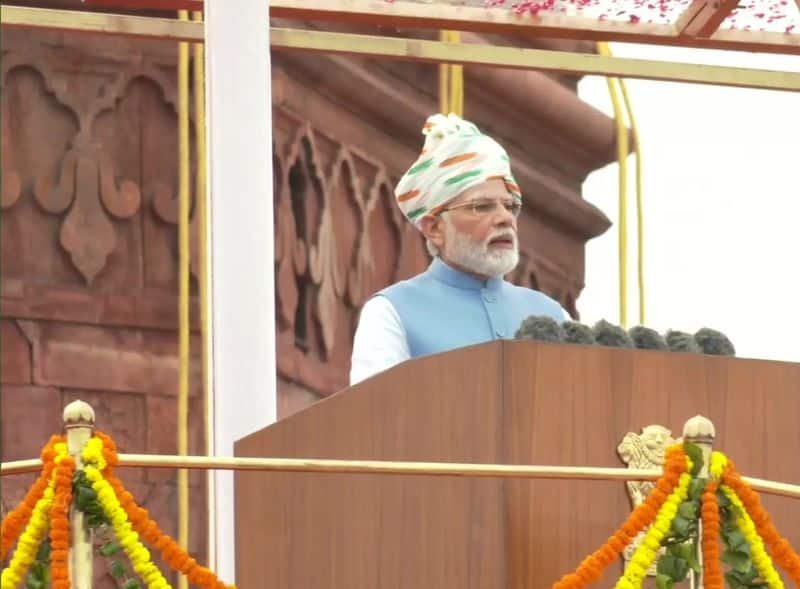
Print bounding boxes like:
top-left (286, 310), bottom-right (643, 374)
top-left (0, 444), bottom-right (66, 589)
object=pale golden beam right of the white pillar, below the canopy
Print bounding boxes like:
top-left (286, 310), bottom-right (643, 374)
top-left (271, 28), bottom-right (800, 91)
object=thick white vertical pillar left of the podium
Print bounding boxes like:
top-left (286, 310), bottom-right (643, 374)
top-left (204, 0), bottom-right (277, 583)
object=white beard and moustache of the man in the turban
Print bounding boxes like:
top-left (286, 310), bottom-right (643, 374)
top-left (444, 218), bottom-right (519, 278)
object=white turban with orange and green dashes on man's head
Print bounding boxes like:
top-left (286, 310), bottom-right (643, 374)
top-left (394, 114), bottom-right (522, 229)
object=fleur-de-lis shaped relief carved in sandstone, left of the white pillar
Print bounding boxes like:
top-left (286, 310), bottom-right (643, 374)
top-left (0, 53), bottom-right (179, 285)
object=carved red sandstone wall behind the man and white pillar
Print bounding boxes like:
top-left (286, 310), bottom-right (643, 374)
top-left (0, 25), bottom-right (613, 587)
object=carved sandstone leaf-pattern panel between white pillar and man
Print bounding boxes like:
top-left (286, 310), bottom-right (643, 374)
top-left (273, 114), bottom-right (427, 392)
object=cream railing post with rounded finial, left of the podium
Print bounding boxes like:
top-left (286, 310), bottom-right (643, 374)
top-left (64, 401), bottom-right (94, 589)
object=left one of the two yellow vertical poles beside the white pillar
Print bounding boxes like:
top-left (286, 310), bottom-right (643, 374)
top-left (178, 10), bottom-right (190, 589)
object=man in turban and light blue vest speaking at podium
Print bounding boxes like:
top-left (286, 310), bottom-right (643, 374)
top-left (350, 114), bottom-right (567, 384)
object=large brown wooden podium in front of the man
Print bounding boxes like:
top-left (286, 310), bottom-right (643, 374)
top-left (235, 341), bottom-right (800, 589)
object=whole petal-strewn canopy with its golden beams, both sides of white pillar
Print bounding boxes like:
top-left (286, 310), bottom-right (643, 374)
top-left (2, 0), bottom-right (800, 91)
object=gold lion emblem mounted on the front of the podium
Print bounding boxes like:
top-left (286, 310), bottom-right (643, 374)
top-left (617, 425), bottom-right (680, 577)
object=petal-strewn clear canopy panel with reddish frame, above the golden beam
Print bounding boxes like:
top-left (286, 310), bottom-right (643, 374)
top-left (270, 0), bottom-right (800, 55)
